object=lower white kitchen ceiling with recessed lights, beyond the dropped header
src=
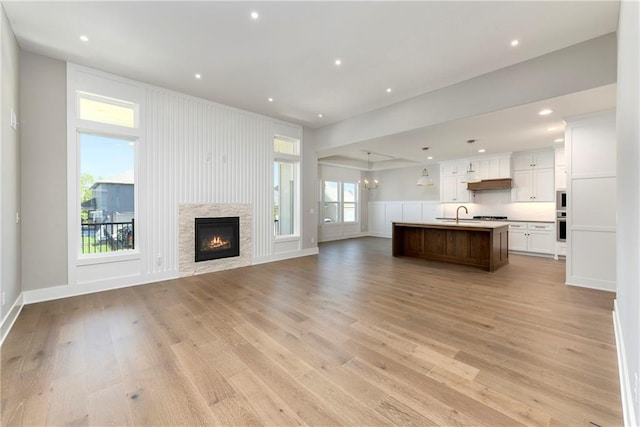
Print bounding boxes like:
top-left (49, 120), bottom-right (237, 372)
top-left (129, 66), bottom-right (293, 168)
top-left (318, 84), bottom-right (616, 170)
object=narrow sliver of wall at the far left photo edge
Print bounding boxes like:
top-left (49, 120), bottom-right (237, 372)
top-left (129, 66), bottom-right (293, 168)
top-left (0, 7), bottom-right (22, 320)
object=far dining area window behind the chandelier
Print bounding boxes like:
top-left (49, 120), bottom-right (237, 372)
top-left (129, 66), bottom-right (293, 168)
top-left (320, 181), bottom-right (358, 224)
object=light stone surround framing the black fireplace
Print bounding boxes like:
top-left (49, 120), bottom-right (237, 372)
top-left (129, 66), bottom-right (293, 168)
top-left (178, 203), bottom-right (253, 277)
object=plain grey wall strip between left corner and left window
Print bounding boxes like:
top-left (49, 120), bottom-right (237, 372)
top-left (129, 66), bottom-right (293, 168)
top-left (20, 51), bottom-right (68, 291)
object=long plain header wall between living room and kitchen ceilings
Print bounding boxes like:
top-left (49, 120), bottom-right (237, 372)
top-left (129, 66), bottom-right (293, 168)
top-left (317, 33), bottom-right (616, 150)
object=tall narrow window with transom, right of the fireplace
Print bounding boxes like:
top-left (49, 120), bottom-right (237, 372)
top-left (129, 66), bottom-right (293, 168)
top-left (273, 136), bottom-right (300, 236)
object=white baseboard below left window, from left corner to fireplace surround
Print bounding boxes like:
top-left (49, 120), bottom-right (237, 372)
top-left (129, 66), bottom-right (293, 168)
top-left (23, 271), bottom-right (178, 304)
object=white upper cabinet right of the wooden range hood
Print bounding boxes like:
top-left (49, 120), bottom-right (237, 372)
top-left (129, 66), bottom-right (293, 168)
top-left (512, 150), bottom-right (555, 202)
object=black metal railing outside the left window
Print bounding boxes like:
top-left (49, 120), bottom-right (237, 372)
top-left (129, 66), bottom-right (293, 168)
top-left (81, 219), bottom-right (135, 254)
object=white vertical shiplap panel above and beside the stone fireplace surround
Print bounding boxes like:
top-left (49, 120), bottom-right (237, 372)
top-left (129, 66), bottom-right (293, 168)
top-left (141, 89), bottom-right (284, 273)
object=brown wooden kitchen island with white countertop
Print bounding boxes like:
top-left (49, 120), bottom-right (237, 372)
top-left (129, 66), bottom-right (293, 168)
top-left (392, 220), bottom-right (509, 271)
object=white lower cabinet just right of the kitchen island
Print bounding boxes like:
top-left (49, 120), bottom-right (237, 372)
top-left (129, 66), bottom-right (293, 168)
top-left (509, 222), bottom-right (556, 255)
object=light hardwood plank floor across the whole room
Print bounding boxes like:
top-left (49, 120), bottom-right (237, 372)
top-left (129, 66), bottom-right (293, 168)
top-left (1, 238), bottom-right (622, 426)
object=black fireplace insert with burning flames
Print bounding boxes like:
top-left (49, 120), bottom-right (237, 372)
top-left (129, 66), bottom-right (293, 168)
top-left (195, 216), bottom-right (240, 262)
